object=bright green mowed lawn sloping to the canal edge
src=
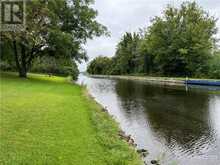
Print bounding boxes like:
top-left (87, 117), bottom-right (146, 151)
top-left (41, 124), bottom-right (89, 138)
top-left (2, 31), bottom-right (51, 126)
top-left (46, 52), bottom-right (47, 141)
top-left (0, 73), bottom-right (141, 165)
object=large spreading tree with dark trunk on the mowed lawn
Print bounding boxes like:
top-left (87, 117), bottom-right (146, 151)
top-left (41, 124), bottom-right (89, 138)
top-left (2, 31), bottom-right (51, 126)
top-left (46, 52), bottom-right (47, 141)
top-left (1, 0), bottom-right (106, 77)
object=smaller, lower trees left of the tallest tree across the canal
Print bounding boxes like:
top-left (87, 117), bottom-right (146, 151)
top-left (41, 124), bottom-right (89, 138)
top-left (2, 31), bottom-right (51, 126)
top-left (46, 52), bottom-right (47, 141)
top-left (87, 33), bottom-right (141, 75)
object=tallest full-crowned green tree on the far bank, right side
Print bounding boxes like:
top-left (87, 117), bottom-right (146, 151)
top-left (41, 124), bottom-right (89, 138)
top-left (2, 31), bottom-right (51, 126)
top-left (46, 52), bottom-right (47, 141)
top-left (147, 2), bottom-right (217, 76)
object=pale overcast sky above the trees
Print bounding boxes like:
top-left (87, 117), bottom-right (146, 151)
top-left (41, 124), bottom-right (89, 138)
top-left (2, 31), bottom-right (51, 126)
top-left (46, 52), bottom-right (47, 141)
top-left (79, 0), bottom-right (220, 71)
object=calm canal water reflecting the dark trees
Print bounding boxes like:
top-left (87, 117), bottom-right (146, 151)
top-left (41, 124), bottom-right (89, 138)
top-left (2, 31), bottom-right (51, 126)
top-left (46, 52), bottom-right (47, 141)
top-left (78, 75), bottom-right (220, 165)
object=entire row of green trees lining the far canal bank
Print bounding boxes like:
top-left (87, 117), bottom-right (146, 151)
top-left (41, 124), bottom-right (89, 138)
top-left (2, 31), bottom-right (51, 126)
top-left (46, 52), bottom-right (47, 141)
top-left (87, 2), bottom-right (220, 78)
